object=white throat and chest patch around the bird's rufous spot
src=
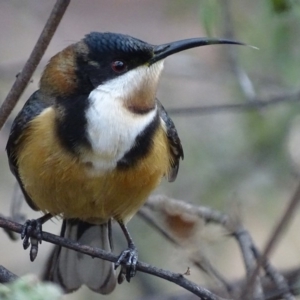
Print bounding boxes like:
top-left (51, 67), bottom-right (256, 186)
top-left (82, 63), bottom-right (163, 173)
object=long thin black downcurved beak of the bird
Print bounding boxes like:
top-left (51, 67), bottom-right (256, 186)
top-left (149, 38), bottom-right (246, 65)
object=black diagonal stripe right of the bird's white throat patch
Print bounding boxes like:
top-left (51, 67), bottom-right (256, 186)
top-left (117, 113), bottom-right (160, 170)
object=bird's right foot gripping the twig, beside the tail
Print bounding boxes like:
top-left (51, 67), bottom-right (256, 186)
top-left (115, 245), bottom-right (138, 283)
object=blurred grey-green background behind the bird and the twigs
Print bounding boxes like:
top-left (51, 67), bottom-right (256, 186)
top-left (0, 0), bottom-right (300, 300)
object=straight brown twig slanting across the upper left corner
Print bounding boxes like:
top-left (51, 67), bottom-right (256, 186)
top-left (0, 0), bottom-right (70, 129)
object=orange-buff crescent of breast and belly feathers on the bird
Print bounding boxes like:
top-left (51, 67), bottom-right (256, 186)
top-left (17, 108), bottom-right (170, 222)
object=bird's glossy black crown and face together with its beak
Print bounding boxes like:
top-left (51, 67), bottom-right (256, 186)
top-left (78, 32), bottom-right (246, 87)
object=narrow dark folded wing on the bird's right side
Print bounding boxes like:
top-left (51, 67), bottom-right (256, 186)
top-left (156, 99), bottom-right (184, 182)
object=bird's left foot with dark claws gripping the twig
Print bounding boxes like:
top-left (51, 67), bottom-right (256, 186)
top-left (21, 219), bottom-right (43, 261)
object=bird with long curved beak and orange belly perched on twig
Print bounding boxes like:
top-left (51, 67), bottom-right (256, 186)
top-left (6, 32), bottom-right (242, 294)
